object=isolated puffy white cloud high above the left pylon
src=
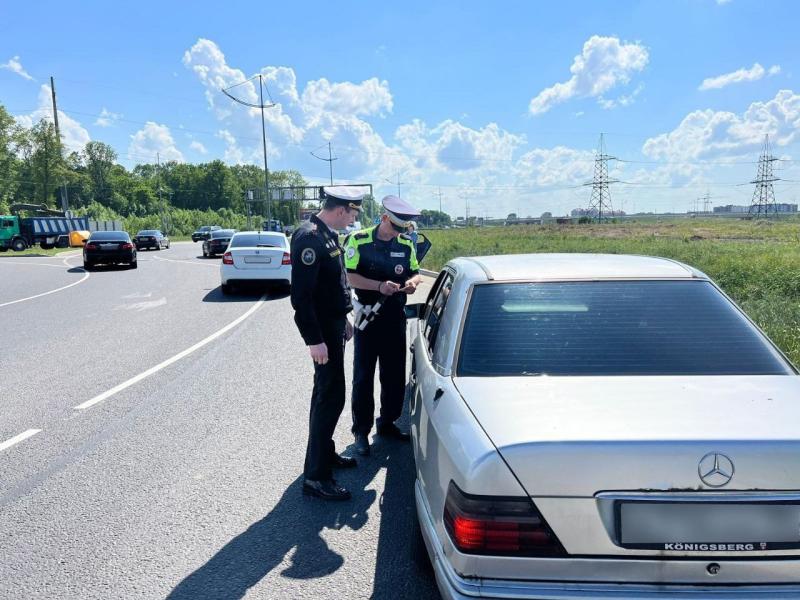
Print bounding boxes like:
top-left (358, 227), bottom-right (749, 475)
top-left (529, 35), bottom-right (650, 115)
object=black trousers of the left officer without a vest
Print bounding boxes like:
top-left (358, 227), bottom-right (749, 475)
top-left (303, 317), bottom-right (345, 481)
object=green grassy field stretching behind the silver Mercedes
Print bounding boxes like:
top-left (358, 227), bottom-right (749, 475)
top-left (422, 219), bottom-right (800, 365)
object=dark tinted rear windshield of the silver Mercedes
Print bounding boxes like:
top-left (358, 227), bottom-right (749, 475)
top-left (457, 281), bottom-right (793, 376)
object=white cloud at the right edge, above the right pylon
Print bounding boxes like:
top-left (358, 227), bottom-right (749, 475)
top-left (642, 90), bottom-right (800, 161)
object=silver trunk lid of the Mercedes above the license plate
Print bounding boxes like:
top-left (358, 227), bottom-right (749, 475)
top-left (454, 376), bottom-right (800, 497)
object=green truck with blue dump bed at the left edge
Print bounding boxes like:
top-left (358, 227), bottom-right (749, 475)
top-left (0, 215), bottom-right (89, 252)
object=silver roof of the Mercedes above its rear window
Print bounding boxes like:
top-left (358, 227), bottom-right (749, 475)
top-left (449, 253), bottom-right (708, 281)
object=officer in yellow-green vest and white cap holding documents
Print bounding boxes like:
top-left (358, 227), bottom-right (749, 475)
top-left (345, 196), bottom-right (421, 456)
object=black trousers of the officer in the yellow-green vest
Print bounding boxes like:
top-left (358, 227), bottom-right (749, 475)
top-left (351, 312), bottom-right (406, 435)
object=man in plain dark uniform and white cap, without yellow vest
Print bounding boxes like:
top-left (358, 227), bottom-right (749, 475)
top-left (291, 186), bottom-right (364, 500)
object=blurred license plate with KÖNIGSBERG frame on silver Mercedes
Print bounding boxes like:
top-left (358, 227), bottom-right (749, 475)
top-left (617, 501), bottom-right (800, 552)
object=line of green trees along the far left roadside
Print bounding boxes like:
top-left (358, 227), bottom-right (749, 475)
top-left (0, 105), bottom-right (388, 235)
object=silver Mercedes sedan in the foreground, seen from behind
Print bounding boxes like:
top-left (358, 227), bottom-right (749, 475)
top-left (408, 254), bottom-right (800, 600)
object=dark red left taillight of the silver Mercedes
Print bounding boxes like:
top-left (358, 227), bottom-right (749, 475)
top-left (444, 481), bottom-right (566, 556)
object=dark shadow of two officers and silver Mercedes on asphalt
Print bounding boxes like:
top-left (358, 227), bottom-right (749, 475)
top-left (167, 390), bottom-right (439, 600)
